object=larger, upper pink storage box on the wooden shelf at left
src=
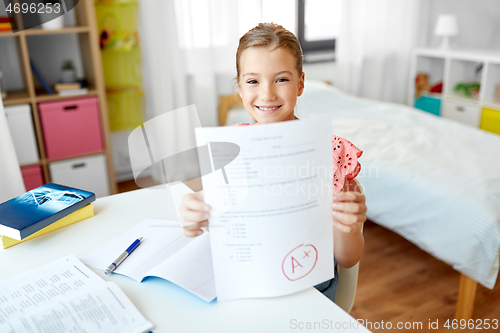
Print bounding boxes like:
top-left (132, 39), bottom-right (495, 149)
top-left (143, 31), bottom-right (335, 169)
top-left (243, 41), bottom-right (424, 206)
top-left (38, 97), bottom-right (103, 159)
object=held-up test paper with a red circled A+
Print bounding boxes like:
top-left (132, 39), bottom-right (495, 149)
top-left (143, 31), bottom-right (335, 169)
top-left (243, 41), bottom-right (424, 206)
top-left (196, 117), bottom-right (333, 300)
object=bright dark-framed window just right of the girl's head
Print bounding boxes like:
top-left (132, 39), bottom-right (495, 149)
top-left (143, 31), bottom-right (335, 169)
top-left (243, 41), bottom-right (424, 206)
top-left (297, 0), bottom-right (342, 62)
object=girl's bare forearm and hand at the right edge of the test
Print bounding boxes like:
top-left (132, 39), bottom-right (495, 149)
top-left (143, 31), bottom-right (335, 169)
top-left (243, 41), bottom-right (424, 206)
top-left (332, 179), bottom-right (366, 268)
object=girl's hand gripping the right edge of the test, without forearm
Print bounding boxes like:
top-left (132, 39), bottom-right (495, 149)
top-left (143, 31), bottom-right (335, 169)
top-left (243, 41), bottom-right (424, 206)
top-left (332, 191), bottom-right (366, 233)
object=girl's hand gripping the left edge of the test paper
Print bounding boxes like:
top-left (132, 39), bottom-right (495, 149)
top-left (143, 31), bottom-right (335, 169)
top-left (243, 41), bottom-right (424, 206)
top-left (179, 191), bottom-right (210, 237)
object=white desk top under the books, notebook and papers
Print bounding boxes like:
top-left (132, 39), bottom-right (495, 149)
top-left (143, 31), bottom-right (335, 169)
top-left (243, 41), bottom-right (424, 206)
top-left (0, 189), bottom-right (368, 333)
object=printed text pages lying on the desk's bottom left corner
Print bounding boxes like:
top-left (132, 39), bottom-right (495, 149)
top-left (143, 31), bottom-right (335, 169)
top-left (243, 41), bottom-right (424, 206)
top-left (0, 256), bottom-right (153, 333)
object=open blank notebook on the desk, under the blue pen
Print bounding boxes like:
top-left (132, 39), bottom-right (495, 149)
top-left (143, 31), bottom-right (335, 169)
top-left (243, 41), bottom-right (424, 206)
top-left (82, 220), bottom-right (216, 302)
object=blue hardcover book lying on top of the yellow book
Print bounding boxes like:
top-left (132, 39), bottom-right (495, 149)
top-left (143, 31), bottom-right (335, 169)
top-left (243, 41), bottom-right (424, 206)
top-left (0, 183), bottom-right (95, 240)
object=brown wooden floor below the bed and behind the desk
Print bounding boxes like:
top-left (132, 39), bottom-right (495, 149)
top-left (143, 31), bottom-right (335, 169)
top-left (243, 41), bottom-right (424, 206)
top-left (118, 180), bottom-right (500, 333)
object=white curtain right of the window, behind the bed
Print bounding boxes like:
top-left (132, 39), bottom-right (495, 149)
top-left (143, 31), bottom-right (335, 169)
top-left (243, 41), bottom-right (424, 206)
top-left (335, 0), bottom-right (422, 103)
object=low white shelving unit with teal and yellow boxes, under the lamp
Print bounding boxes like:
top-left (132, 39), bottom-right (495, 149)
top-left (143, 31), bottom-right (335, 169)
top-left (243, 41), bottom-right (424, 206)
top-left (408, 49), bottom-right (500, 134)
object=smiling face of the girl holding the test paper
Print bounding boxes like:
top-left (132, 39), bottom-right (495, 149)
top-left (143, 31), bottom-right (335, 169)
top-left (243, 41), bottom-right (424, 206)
top-left (238, 47), bottom-right (304, 124)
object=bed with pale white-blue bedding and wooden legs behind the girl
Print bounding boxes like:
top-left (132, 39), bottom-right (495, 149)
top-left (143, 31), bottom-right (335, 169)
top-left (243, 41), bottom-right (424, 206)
top-left (219, 80), bottom-right (500, 319)
